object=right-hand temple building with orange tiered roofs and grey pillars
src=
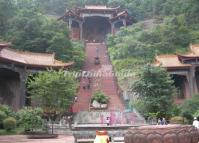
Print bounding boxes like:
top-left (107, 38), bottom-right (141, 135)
top-left (155, 45), bottom-right (199, 103)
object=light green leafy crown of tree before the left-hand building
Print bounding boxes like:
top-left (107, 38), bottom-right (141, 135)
top-left (28, 70), bottom-right (77, 113)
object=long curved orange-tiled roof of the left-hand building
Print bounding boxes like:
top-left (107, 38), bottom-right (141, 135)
top-left (0, 44), bottom-right (73, 68)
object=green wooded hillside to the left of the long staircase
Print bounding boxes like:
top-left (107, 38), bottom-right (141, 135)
top-left (0, 0), bottom-right (84, 68)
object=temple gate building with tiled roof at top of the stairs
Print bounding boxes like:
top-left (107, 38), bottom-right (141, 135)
top-left (58, 5), bottom-right (132, 42)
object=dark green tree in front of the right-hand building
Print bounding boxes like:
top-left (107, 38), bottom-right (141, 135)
top-left (133, 66), bottom-right (175, 117)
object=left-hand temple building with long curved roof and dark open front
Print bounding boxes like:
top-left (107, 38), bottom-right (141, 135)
top-left (0, 43), bottom-right (73, 110)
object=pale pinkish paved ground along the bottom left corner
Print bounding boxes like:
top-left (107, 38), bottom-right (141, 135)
top-left (0, 135), bottom-right (74, 143)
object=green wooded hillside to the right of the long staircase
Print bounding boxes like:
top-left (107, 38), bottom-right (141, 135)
top-left (107, 0), bottom-right (199, 85)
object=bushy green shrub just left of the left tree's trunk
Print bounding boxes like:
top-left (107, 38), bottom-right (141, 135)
top-left (17, 107), bottom-right (43, 131)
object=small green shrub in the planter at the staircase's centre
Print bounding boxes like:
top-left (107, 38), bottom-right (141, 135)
top-left (91, 91), bottom-right (109, 104)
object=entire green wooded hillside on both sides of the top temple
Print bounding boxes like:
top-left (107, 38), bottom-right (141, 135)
top-left (0, 0), bottom-right (199, 78)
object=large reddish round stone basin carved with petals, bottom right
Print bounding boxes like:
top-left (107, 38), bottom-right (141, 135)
top-left (124, 125), bottom-right (199, 143)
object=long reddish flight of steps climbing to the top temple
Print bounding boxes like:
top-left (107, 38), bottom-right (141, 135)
top-left (73, 43), bottom-right (124, 112)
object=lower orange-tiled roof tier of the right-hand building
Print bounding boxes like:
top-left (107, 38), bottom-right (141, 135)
top-left (155, 55), bottom-right (191, 68)
